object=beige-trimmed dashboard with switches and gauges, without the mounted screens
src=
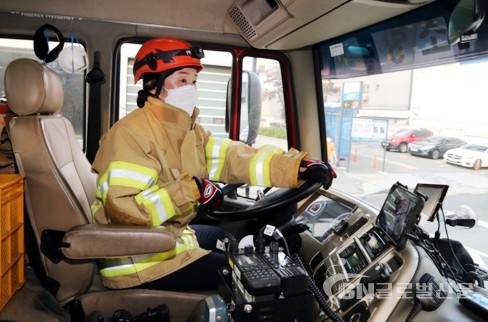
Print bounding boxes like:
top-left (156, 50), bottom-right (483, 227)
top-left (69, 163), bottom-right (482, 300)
top-left (297, 191), bottom-right (484, 321)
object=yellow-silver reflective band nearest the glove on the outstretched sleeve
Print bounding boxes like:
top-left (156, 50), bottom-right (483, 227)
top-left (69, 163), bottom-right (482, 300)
top-left (249, 145), bottom-right (284, 187)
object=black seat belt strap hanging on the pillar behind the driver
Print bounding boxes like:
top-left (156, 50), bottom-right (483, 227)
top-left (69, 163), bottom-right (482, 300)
top-left (85, 51), bottom-right (106, 163)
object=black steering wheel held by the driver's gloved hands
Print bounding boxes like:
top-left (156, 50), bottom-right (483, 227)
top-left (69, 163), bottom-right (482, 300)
top-left (207, 181), bottom-right (322, 221)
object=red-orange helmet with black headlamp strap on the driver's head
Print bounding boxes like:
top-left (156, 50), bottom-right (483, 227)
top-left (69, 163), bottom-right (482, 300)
top-left (133, 38), bottom-right (204, 83)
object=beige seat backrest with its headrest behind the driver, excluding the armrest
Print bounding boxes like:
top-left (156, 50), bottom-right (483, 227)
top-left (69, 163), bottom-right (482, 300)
top-left (5, 58), bottom-right (96, 302)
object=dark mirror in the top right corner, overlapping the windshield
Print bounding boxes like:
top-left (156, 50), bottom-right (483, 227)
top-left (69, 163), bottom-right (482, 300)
top-left (447, 0), bottom-right (485, 45)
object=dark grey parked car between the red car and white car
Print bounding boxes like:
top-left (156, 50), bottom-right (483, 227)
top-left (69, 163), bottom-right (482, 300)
top-left (408, 135), bottom-right (468, 159)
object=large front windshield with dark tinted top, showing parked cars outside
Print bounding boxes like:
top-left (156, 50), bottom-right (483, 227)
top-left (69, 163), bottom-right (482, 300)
top-left (316, 1), bottom-right (488, 265)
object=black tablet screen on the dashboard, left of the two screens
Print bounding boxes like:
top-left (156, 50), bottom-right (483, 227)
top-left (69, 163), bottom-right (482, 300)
top-left (376, 183), bottom-right (424, 249)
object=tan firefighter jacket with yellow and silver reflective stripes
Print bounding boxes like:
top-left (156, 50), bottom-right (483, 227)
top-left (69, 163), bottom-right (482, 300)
top-left (92, 97), bottom-right (305, 288)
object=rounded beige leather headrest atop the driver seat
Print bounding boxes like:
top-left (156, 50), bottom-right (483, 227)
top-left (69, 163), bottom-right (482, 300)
top-left (5, 58), bottom-right (64, 115)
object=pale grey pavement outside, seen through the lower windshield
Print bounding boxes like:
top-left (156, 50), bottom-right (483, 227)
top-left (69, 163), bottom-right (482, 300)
top-left (333, 143), bottom-right (488, 267)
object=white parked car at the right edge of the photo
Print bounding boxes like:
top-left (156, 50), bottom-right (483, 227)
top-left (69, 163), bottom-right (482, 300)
top-left (444, 144), bottom-right (488, 170)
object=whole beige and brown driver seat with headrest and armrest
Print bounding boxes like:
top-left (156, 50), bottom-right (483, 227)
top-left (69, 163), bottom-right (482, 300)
top-left (4, 58), bottom-right (208, 322)
